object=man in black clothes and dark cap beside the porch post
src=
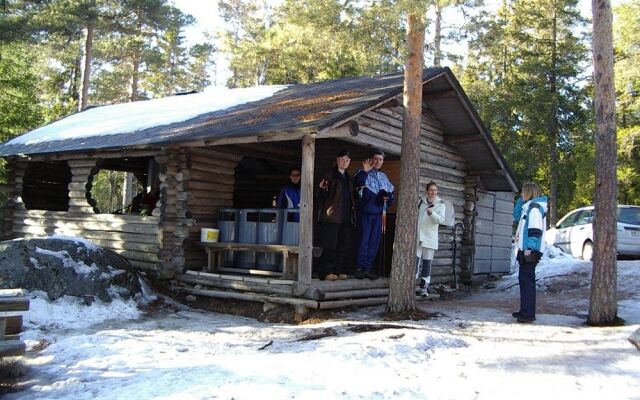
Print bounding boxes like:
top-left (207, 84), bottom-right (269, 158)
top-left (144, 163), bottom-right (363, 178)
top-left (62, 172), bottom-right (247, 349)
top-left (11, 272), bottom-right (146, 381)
top-left (317, 151), bottom-right (355, 281)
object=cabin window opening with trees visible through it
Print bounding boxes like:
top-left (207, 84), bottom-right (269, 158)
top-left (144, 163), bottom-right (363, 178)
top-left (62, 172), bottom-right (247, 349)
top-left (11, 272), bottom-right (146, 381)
top-left (87, 157), bottom-right (159, 216)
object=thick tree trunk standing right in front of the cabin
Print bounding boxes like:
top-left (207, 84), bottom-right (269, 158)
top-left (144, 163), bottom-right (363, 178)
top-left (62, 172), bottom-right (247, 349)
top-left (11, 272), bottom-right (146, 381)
top-left (387, 13), bottom-right (425, 313)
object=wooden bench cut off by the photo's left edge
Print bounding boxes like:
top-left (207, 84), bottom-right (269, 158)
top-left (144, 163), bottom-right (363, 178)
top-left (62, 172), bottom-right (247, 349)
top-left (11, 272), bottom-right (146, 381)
top-left (0, 289), bottom-right (29, 358)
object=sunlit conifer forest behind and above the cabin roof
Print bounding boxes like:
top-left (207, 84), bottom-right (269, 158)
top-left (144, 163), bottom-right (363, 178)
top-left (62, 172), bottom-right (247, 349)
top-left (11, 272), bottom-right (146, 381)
top-left (0, 0), bottom-right (640, 222)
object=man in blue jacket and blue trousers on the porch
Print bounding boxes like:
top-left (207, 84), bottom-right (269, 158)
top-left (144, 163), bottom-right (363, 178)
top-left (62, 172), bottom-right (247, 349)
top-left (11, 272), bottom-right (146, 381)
top-left (355, 150), bottom-right (394, 280)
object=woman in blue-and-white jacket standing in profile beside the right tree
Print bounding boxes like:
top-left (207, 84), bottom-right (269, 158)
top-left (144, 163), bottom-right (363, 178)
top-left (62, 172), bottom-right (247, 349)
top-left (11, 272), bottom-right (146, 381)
top-left (512, 182), bottom-right (548, 323)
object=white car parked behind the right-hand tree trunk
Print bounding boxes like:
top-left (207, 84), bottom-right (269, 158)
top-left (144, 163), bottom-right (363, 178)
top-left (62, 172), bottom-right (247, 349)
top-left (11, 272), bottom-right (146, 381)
top-left (544, 205), bottom-right (640, 261)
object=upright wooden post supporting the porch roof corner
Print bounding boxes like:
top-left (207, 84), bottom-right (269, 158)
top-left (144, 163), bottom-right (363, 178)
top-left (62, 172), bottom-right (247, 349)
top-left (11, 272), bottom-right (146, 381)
top-left (298, 135), bottom-right (316, 285)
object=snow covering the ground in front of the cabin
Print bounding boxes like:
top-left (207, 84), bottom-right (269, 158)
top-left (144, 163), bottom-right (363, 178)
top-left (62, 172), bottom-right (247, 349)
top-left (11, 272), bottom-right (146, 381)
top-left (6, 255), bottom-right (640, 400)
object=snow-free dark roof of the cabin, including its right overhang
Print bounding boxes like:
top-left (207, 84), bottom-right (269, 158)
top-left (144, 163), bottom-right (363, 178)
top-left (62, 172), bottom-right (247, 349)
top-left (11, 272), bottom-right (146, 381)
top-left (0, 68), bottom-right (517, 191)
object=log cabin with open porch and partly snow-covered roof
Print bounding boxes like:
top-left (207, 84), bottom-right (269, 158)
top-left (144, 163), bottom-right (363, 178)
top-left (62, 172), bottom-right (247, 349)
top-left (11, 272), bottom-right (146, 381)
top-left (0, 68), bottom-right (518, 309)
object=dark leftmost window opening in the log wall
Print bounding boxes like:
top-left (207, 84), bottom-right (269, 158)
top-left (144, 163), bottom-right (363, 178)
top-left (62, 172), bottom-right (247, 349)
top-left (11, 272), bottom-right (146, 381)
top-left (22, 161), bottom-right (71, 211)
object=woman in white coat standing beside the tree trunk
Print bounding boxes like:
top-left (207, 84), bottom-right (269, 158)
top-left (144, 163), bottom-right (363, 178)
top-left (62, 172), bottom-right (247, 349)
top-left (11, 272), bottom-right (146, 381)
top-left (416, 181), bottom-right (445, 297)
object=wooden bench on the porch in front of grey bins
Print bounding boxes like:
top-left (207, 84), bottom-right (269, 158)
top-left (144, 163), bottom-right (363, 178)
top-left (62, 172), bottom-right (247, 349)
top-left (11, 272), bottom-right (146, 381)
top-left (200, 242), bottom-right (322, 279)
